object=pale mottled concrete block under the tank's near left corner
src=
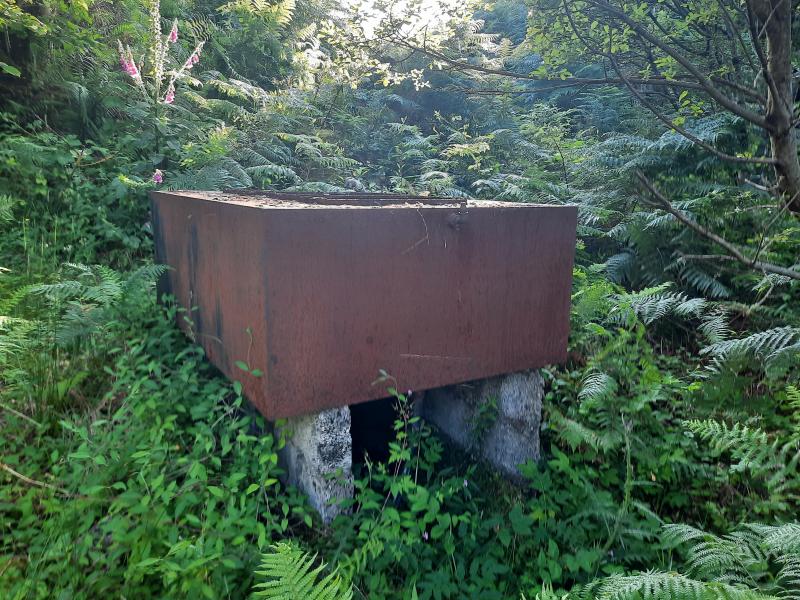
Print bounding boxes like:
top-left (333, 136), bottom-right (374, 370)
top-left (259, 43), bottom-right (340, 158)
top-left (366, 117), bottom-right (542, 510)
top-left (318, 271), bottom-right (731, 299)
top-left (279, 406), bottom-right (353, 523)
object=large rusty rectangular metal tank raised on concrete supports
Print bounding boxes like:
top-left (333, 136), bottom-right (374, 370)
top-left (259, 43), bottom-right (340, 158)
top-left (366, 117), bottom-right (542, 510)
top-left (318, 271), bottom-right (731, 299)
top-left (152, 192), bottom-right (576, 419)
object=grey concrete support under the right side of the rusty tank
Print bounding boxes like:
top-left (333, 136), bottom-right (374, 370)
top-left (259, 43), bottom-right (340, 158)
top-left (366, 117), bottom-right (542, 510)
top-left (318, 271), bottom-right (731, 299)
top-left (418, 371), bottom-right (544, 479)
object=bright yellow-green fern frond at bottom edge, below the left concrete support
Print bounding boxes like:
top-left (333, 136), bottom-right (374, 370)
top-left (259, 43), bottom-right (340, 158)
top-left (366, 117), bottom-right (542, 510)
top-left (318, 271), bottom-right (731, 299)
top-left (253, 542), bottom-right (353, 600)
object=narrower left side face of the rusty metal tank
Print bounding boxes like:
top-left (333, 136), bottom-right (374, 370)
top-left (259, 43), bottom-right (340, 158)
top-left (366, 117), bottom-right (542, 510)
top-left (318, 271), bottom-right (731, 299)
top-left (151, 193), bottom-right (269, 416)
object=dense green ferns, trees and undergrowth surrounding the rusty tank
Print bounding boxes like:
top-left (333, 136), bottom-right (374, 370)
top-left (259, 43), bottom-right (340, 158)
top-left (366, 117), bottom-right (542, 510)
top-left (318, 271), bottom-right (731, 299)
top-left (0, 0), bottom-right (800, 599)
